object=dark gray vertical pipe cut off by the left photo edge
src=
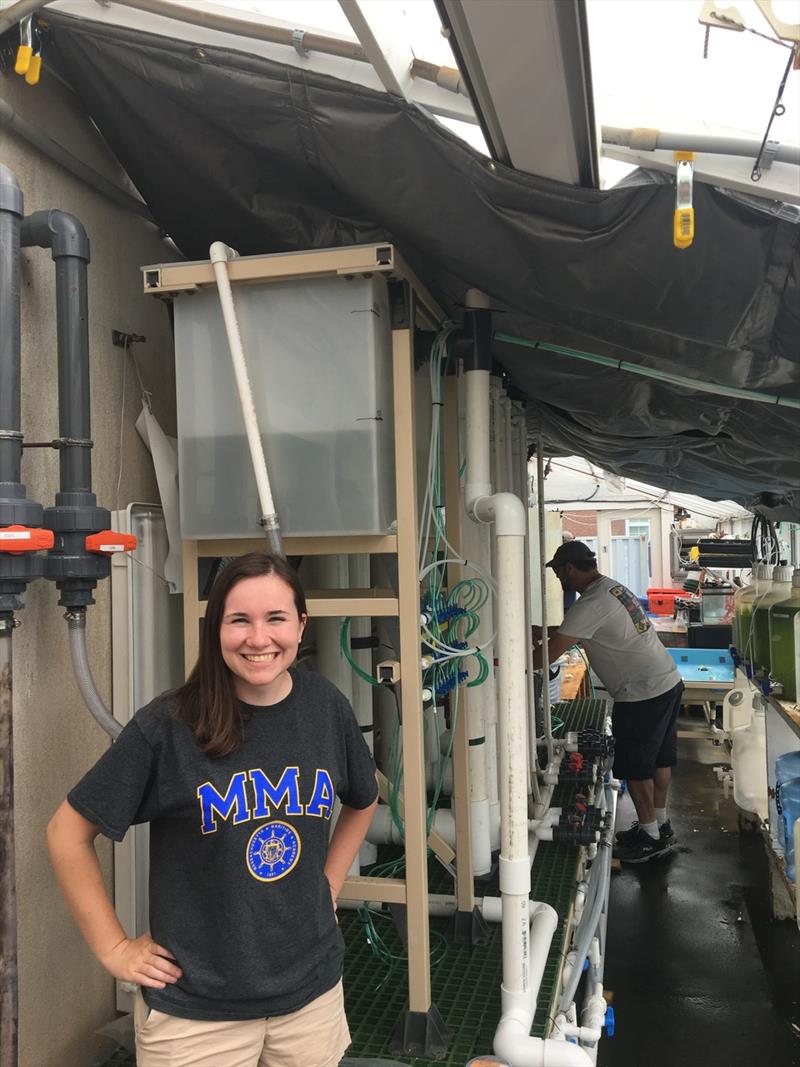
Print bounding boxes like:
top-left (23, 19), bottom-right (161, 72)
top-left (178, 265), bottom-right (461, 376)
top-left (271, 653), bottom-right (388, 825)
top-left (0, 163), bottom-right (25, 486)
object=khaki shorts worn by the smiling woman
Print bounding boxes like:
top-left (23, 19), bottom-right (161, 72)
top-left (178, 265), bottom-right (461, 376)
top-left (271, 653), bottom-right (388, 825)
top-left (133, 982), bottom-right (350, 1067)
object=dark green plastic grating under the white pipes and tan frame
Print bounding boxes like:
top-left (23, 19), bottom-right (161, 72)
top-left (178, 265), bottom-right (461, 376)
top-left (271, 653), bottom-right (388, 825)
top-left (340, 699), bottom-right (607, 1067)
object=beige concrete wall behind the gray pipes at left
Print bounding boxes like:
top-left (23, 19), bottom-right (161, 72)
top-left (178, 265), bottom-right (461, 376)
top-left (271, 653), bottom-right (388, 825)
top-left (0, 70), bottom-right (175, 1067)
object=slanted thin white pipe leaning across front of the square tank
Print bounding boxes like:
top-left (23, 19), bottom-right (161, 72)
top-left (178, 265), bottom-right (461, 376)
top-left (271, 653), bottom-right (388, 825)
top-left (208, 241), bottom-right (283, 554)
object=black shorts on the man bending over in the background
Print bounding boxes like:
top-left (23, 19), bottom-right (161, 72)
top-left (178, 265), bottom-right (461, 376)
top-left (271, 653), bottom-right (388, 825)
top-left (611, 682), bottom-right (684, 781)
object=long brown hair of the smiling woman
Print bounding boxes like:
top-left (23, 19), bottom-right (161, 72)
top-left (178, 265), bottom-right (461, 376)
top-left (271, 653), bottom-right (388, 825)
top-left (175, 552), bottom-right (306, 758)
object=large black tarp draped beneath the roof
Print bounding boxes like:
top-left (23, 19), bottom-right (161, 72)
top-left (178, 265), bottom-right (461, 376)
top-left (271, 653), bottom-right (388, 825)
top-left (39, 14), bottom-right (800, 517)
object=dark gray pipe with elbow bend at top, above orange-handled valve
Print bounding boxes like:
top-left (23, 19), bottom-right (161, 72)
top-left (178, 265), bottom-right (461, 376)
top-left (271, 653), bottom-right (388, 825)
top-left (22, 210), bottom-right (92, 493)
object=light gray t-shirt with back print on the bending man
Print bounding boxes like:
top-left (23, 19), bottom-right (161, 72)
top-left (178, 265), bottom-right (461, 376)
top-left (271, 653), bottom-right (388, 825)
top-left (558, 576), bottom-right (681, 702)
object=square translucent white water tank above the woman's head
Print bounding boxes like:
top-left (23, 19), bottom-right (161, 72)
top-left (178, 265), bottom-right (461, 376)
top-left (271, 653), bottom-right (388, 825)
top-left (175, 275), bottom-right (396, 539)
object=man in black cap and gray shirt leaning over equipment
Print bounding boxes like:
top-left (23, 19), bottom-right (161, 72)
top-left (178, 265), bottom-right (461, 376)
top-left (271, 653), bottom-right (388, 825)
top-left (533, 541), bottom-right (684, 863)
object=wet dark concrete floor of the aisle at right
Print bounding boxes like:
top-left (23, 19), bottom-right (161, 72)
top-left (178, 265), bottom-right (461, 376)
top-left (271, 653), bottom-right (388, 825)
top-left (598, 714), bottom-right (800, 1067)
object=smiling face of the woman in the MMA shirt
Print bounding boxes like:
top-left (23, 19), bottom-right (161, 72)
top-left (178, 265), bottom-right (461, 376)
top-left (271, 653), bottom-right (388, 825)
top-left (220, 574), bottom-right (306, 705)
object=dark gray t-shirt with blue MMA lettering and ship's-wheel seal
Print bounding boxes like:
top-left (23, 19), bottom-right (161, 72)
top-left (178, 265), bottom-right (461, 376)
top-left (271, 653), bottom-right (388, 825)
top-left (67, 669), bottom-right (378, 1020)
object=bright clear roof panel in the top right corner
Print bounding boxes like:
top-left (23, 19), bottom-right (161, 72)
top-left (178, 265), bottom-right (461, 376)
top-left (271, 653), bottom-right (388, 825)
top-left (587, 0), bottom-right (800, 143)
